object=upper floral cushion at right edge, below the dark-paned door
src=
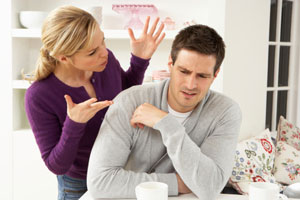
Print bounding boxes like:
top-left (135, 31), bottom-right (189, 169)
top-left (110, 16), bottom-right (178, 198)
top-left (277, 116), bottom-right (300, 151)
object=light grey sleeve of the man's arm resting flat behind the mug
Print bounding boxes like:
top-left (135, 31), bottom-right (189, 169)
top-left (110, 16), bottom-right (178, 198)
top-left (87, 99), bottom-right (178, 198)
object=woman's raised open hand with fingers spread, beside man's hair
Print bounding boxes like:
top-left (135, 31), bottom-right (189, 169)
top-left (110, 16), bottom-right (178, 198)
top-left (128, 16), bottom-right (165, 59)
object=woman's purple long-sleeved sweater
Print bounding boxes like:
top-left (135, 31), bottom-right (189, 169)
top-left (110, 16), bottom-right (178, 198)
top-left (25, 50), bottom-right (149, 179)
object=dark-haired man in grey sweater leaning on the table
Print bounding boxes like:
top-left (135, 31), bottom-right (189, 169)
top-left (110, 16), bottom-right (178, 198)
top-left (87, 25), bottom-right (241, 200)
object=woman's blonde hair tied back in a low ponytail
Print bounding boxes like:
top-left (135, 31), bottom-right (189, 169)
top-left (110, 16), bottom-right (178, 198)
top-left (32, 6), bottom-right (98, 81)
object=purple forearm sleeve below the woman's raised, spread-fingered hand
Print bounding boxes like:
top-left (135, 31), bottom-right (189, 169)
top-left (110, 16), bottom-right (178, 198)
top-left (121, 54), bottom-right (150, 90)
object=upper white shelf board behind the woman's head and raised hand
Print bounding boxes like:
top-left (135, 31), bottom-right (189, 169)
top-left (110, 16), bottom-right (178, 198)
top-left (11, 29), bottom-right (178, 39)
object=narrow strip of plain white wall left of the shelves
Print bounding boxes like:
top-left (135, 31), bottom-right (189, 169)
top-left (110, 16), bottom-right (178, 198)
top-left (0, 0), bottom-right (12, 199)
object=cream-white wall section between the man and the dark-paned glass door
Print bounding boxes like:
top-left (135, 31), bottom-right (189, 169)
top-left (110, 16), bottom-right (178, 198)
top-left (223, 0), bottom-right (270, 139)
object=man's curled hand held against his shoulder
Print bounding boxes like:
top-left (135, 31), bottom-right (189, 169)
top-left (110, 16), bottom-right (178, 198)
top-left (130, 103), bottom-right (168, 128)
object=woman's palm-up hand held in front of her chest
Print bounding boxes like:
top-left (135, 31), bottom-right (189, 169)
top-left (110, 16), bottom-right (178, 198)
top-left (64, 95), bottom-right (113, 123)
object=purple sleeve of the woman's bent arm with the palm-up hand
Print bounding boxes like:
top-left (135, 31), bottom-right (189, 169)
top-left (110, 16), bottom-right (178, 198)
top-left (25, 89), bottom-right (86, 174)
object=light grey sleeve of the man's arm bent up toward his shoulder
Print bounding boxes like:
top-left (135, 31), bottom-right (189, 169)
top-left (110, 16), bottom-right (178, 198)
top-left (154, 106), bottom-right (241, 199)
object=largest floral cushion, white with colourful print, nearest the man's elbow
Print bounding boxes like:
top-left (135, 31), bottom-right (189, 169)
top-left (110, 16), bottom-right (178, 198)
top-left (229, 129), bottom-right (276, 194)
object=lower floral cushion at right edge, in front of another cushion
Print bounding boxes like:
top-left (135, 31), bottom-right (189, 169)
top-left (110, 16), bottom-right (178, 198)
top-left (274, 141), bottom-right (300, 184)
